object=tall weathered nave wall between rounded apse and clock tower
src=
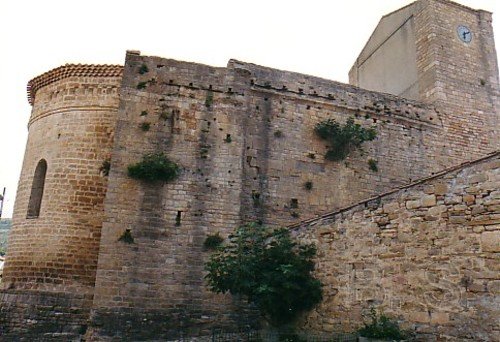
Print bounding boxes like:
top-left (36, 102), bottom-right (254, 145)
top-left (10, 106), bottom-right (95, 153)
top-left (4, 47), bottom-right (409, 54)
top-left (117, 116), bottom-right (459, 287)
top-left (89, 48), bottom-right (460, 338)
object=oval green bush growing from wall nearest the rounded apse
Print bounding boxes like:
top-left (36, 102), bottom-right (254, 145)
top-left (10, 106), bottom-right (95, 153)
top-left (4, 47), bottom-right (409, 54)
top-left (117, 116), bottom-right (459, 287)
top-left (128, 152), bottom-right (179, 182)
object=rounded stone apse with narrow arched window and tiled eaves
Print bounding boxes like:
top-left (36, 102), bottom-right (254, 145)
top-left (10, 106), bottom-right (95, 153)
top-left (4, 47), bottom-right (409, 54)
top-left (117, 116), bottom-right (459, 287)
top-left (0, 65), bottom-right (123, 332)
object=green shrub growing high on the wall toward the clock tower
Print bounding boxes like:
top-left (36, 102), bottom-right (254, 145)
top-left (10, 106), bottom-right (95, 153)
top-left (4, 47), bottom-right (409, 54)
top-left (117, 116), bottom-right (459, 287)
top-left (314, 118), bottom-right (377, 161)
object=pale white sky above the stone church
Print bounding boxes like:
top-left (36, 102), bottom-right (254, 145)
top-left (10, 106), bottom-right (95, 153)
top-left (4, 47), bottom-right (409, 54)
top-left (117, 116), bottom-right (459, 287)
top-left (0, 0), bottom-right (500, 217)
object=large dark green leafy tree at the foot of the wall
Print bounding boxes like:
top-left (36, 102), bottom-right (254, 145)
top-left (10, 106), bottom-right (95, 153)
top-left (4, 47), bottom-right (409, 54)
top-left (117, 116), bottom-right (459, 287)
top-left (205, 223), bottom-right (322, 326)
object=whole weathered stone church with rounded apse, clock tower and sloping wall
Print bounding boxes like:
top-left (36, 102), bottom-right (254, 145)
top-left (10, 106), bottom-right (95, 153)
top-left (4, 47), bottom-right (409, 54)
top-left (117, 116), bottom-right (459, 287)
top-left (0, 0), bottom-right (500, 341)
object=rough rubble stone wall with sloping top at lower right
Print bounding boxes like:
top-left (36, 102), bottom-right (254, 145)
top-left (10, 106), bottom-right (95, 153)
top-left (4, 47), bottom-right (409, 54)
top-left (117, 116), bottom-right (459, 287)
top-left (292, 152), bottom-right (500, 341)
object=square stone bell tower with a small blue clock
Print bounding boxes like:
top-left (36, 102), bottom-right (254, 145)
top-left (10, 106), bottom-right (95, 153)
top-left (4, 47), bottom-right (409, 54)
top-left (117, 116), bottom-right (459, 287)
top-left (349, 0), bottom-right (500, 165)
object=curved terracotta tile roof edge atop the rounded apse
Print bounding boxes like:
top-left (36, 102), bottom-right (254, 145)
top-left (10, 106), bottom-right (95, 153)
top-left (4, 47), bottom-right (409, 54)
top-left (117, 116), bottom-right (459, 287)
top-left (27, 64), bottom-right (123, 105)
